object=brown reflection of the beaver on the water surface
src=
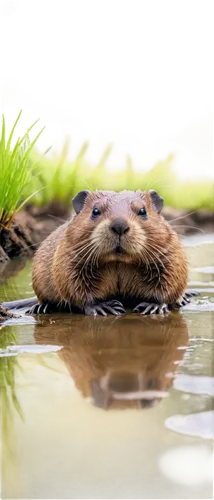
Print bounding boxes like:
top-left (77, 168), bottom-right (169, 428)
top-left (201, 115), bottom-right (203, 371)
top-left (35, 313), bottom-right (188, 409)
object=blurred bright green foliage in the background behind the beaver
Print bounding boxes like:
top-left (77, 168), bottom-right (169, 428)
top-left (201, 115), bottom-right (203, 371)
top-left (25, 132), bottom-right (214, 210)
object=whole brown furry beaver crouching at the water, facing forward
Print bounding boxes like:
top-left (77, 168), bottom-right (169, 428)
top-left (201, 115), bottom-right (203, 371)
top-left (25, 190), bottom-right (199, 315)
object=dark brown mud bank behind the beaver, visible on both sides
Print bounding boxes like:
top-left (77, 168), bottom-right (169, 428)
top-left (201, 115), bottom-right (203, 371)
top-left (0, 205), bottom-right (214, 263)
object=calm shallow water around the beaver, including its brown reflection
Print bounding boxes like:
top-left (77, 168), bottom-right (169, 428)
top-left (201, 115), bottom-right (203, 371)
top-left (0, 235), bottom-right (214, 500)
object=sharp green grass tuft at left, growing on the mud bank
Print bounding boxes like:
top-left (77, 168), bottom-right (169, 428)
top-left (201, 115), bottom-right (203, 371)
top-left (0, 110), bottom-right (46, 227)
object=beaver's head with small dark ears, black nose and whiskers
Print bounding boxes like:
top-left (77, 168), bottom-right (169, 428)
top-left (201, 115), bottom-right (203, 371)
top-left (69, 190), bottom-right (168, 262)
